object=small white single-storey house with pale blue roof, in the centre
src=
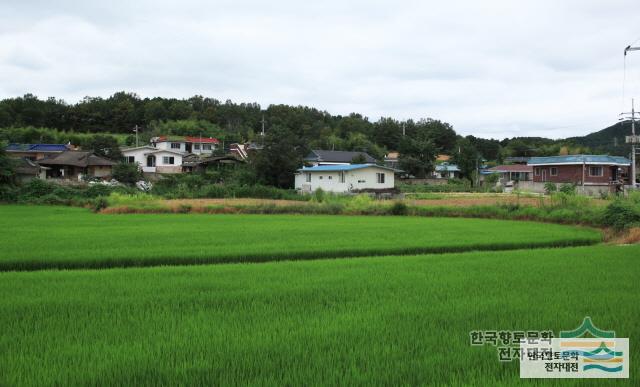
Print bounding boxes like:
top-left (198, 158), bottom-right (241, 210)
top-left (295, 164), bottom-right (399, 193)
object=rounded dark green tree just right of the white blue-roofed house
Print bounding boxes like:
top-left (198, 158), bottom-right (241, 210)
top-left (398, 135), bottom-right (438, 179)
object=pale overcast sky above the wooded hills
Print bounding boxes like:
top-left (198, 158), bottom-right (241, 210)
top-left (0, 0), bottom-right (640, 138)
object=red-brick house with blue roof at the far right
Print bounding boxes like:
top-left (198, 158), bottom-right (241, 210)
top-left (528, 155), bottom-right (631, 194)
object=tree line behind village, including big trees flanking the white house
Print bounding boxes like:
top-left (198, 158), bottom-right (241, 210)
top-left (0, 91), bottom-right (600, 186)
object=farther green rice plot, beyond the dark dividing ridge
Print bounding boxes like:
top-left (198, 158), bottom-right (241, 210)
top-left (0, 206), bottom-right (602, 271)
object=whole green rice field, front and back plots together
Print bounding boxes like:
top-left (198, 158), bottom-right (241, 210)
top-left (0, 206), bottom-right (640, 386)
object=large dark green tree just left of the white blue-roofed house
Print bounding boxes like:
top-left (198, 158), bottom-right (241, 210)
top-left (250, 125), bottom-right (305, 188)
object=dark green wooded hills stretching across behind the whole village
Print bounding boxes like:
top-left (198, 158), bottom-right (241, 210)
top-left (0, 92), bottom-right (630, 161)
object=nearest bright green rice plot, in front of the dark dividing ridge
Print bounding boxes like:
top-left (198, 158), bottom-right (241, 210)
top-left (0, 247), bottom-right (640, 386)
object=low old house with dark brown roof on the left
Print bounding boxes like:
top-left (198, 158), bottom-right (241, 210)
top-left (38, 151), bottom-right (116, 180)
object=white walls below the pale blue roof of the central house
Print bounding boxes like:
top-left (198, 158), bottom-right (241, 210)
top-left (295, 166), bottom-right (395, 193)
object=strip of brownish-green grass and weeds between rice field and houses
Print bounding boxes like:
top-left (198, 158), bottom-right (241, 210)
top-left (100, 193), bottom-right (624, 228)
